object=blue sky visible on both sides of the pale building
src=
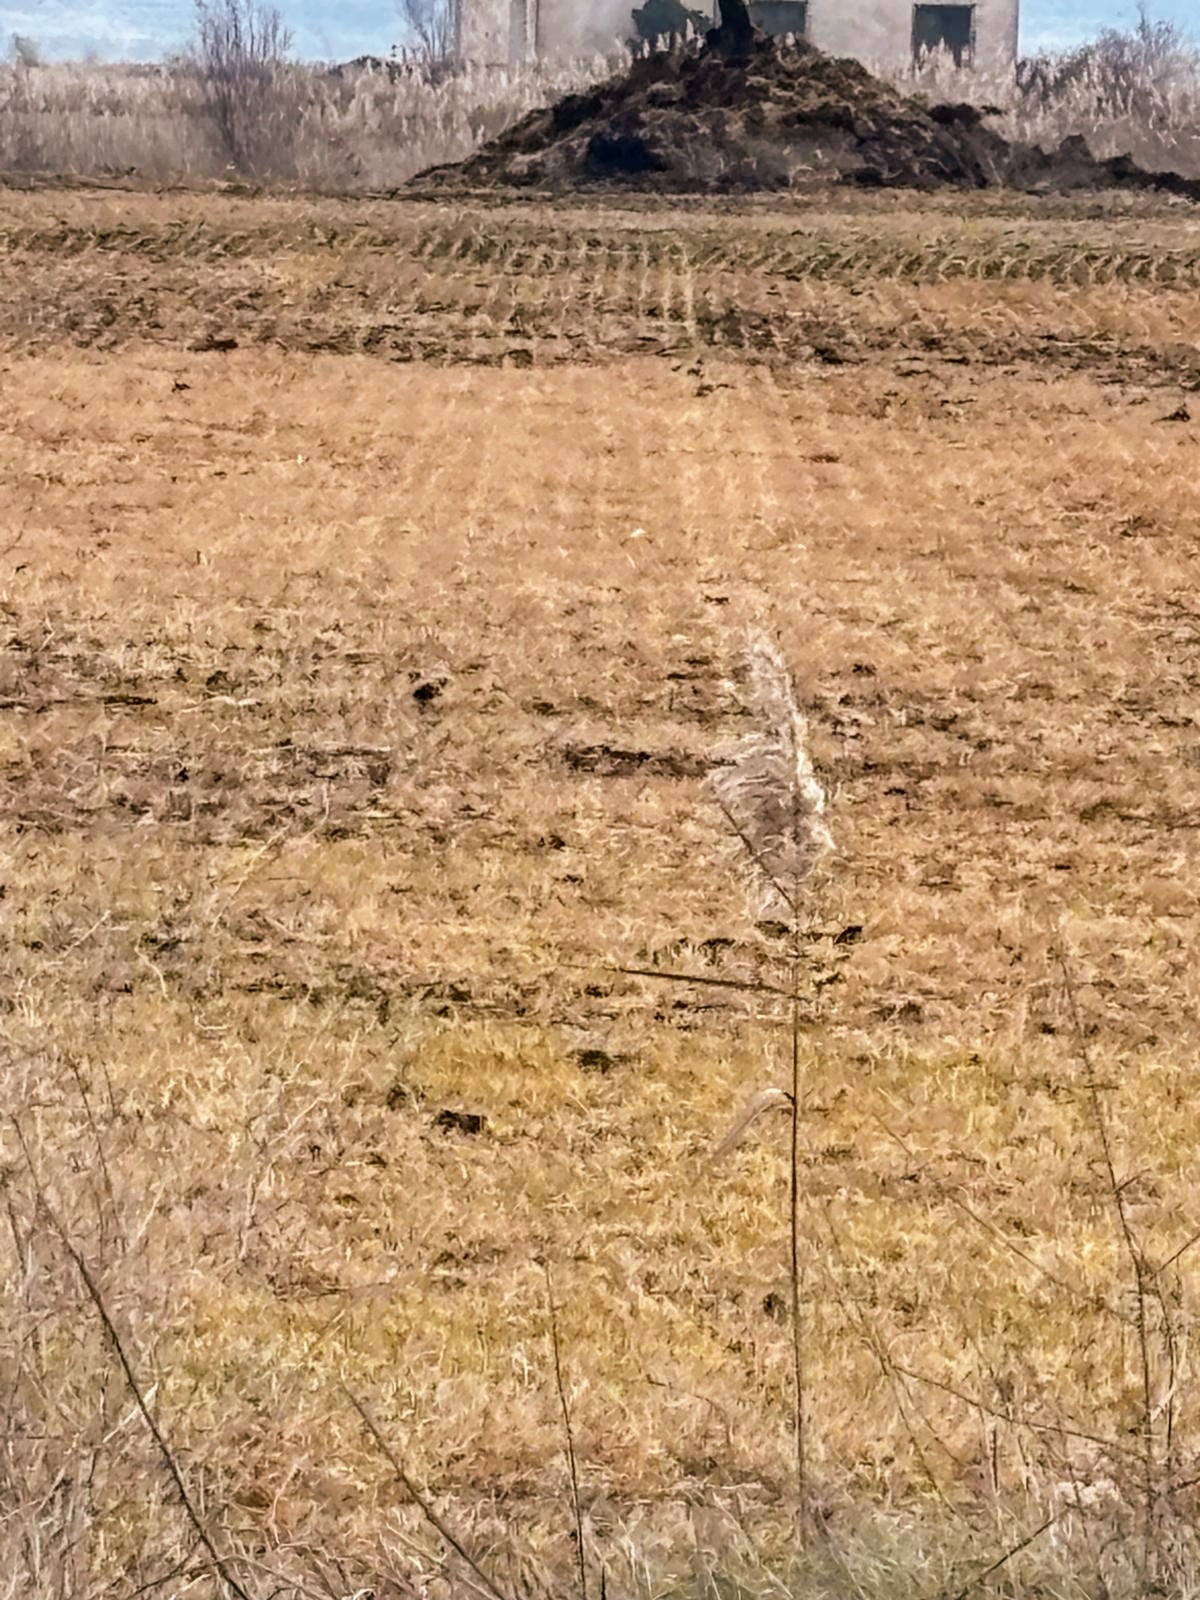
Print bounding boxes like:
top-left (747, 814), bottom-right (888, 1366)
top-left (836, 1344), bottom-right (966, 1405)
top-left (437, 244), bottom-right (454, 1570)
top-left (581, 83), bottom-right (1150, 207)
top-left (0, 0), bottom-right (1200, 61)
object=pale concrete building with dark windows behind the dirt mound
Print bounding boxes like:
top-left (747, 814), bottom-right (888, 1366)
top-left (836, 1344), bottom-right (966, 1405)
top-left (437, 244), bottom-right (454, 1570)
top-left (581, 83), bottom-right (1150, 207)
top-left (453, 0), bottom-right (1021, 72)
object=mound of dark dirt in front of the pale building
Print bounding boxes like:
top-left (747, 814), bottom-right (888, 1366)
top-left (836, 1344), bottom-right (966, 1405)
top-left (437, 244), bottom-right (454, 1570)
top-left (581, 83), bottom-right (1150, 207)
top-left (416, 30), bottom-right (1200, 200)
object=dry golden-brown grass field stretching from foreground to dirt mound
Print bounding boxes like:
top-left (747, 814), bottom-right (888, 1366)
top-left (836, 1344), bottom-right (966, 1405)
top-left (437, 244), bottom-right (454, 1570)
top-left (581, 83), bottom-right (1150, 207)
top-left (0, 175), bottom-right (1200, 1600)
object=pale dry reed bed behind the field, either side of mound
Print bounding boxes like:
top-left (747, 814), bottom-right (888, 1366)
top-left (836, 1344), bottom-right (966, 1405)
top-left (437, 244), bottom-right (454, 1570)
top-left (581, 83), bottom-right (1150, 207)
top-left (0, 42), bottom-right (1200, 192)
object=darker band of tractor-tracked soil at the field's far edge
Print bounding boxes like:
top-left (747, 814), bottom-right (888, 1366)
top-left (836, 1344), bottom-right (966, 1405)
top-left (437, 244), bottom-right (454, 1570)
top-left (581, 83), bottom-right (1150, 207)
top-left (0, 192), bottom-right (1200, 387)
